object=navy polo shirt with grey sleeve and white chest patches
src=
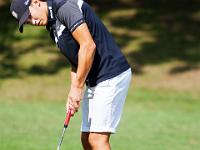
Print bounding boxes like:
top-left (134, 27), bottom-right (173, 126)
top-left (47, 0), bottom-right (130, 87)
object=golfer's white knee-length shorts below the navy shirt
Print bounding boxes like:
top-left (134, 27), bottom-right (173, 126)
top-left (81, 69), bottom-right (132, 133)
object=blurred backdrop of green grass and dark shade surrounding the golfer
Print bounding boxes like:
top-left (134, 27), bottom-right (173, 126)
top-left (0, 0), bottom-right (200, 150)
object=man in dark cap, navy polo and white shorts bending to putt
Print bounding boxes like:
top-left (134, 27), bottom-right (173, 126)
top-left (10, 0), bottom-right (131, 150)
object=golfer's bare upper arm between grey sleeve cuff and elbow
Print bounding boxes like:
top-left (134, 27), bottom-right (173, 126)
top-left (72, 23), bottom-right (95, 46)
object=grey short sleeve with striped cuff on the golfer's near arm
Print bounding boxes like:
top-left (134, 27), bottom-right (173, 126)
top-left (57, 0), bottom-right (85, 32)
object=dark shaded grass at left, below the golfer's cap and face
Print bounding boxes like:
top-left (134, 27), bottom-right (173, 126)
top-left (0, 2), bottom-right (69, 79)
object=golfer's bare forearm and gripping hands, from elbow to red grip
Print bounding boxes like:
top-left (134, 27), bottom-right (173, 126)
top-left (66, 44), bottom-right (95, 114)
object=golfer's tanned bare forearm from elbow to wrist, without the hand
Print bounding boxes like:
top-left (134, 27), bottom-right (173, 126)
top-left (73, 42), bottom-right (96, 88)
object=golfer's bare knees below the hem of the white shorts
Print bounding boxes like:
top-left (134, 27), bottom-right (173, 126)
top-left (81, 132), bottom-right (111, 150)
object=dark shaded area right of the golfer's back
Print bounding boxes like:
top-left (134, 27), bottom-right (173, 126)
top-left (91, 0), bottom-right (200, 74)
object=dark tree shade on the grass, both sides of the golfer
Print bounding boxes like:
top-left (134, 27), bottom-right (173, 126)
top-left (0, 0), bottom-right (200, 78)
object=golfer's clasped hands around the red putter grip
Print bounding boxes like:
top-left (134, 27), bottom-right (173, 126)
top-left (67, 86), bottom-right (83, 116)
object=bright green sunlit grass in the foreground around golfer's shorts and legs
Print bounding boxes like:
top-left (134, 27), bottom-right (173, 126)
top-left (0, 88), bottom-right (200, 150)
